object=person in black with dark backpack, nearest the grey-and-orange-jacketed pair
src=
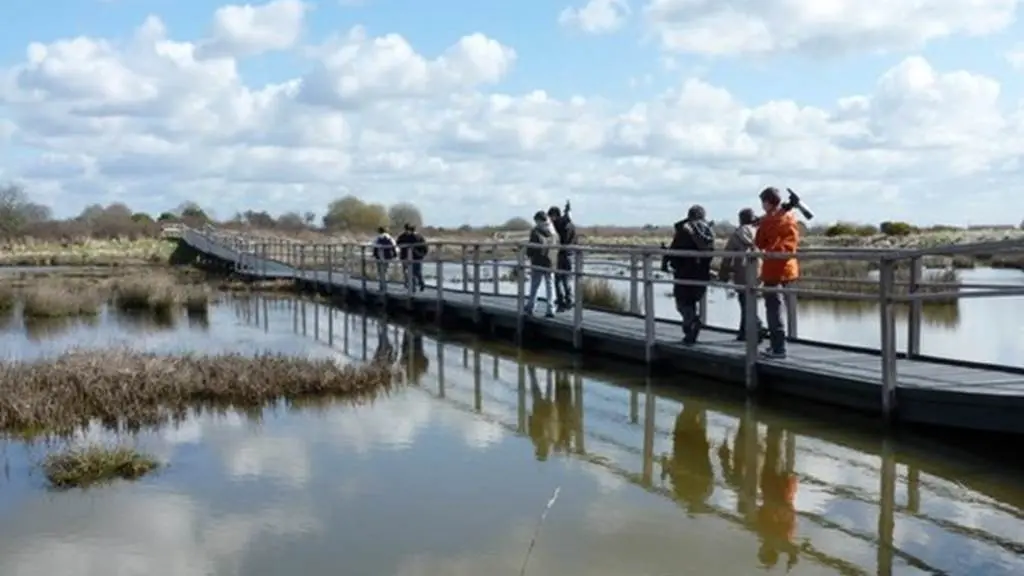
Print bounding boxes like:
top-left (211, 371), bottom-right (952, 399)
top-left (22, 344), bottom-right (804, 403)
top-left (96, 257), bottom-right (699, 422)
top-left (667, 205), bottom-right (715, 344)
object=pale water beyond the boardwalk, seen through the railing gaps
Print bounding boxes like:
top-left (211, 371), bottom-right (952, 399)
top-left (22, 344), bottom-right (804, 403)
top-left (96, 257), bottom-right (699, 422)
top-left (431, 260), bottom-right (1024, 366)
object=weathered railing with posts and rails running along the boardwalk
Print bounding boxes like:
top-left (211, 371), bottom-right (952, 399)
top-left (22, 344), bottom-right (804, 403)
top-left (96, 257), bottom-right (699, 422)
top-left (186, 229), bottom-right (1024, 418)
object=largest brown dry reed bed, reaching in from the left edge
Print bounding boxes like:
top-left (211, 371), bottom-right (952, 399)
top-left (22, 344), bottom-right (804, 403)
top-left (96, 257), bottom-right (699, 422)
top-left (0, 351), bottom-right (397, 434)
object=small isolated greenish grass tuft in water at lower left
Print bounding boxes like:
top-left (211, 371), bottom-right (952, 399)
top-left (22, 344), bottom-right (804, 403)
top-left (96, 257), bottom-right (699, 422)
top-left (42, 445), bottom-right (160, 490)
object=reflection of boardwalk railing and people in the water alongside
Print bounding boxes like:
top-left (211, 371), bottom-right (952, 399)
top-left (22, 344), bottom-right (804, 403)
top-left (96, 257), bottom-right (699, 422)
top-left (235, 298), bottom-right (1024, 574)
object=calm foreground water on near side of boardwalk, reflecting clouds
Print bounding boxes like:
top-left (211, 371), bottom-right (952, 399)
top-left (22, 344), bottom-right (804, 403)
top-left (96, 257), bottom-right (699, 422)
top-left (0, 298), bottom-right (1024, 576)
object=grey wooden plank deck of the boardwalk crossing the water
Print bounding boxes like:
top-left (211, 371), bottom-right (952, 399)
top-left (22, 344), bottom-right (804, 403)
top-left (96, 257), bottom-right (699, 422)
top-left (181, 226), bottom-right (1024, 434)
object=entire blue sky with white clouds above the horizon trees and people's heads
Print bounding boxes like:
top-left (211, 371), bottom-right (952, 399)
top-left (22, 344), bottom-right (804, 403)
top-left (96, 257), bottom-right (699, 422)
top-left (0, 0), bottom-right (1024, 225)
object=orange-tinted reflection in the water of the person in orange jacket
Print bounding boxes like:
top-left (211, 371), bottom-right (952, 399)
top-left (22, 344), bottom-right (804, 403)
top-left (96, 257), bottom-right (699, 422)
top-left (758, 425), bottom-right (798, 570)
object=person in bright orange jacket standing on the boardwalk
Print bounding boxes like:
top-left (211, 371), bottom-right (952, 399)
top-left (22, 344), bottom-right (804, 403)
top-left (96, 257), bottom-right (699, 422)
top-left (754, 188), bottom-right (800, 358)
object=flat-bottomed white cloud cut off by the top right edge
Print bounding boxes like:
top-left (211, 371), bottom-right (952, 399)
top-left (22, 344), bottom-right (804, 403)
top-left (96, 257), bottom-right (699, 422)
top-left (644, 0), bottom-right (1019, 55)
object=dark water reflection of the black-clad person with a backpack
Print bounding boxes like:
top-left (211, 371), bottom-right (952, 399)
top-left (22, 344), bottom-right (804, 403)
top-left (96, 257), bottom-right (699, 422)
top-left (662, 400), bottom-right (715, 513)
